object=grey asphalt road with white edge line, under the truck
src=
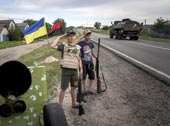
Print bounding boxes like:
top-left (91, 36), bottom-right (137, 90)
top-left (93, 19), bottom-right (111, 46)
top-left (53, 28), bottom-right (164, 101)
top-left (79, 29), bottom-right (170, 82)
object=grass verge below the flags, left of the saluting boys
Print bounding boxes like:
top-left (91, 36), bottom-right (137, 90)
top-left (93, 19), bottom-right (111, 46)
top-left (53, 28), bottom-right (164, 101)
top-left (18, 45), bottom-right (61, 96)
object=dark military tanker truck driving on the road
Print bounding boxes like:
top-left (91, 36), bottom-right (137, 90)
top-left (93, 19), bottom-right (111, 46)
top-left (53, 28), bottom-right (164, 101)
top-left (110, 18), bottom-right (143, 40)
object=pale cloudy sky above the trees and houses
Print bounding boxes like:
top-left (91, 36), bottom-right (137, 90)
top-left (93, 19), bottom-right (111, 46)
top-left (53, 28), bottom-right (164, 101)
top-left (0, 0), bottom-right (170, 26)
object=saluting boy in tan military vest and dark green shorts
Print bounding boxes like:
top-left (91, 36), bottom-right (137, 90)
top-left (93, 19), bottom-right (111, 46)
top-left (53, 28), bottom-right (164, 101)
top-left (51, 29), bottom-right (82, 108)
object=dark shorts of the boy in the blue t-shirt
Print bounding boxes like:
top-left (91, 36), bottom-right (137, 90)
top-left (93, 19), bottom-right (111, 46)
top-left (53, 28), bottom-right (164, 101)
top-left (83, 63), bottom-right (95, 80)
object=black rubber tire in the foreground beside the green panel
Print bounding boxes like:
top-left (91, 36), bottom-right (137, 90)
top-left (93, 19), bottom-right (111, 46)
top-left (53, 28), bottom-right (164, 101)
top-left (43, 103), bottom-right (67, 126)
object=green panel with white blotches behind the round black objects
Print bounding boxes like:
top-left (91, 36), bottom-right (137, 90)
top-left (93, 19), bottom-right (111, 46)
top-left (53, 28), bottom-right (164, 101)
top-left (0, 66), bottom-right (47, 126)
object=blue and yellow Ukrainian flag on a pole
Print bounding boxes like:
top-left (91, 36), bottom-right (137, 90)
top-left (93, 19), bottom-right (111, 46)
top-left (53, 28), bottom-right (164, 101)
top-left (23, 18), bottom-right (47, 44)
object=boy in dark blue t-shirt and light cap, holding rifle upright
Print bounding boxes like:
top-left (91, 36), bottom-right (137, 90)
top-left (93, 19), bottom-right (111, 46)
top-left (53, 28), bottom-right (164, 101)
top-left (78, 30), bottom-right (96, 94)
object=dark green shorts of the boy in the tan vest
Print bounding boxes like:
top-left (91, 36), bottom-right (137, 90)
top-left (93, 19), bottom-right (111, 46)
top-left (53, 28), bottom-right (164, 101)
top-left (61, 68), bottom-right (78, 90)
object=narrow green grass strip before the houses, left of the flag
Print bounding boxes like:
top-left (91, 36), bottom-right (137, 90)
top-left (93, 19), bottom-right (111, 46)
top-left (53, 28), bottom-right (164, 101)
top-left (0, 41), bottom-right (25, 49)
